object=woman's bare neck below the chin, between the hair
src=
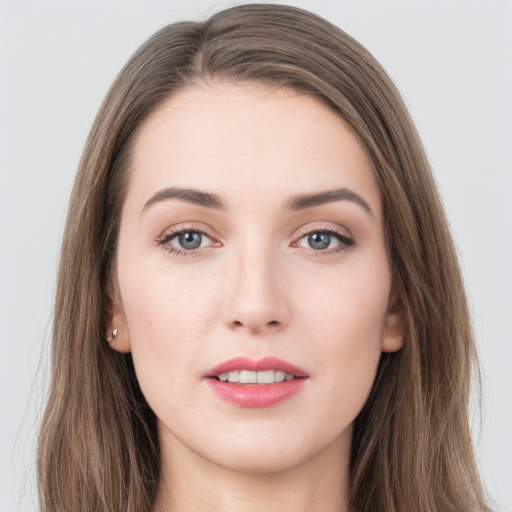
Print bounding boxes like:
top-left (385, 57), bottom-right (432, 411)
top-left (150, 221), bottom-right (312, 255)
top-left (153, 428), bottom-right (350, 512)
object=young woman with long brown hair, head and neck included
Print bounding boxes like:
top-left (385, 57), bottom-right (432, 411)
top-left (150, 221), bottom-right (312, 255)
top-left (39, 4), bottom-right (489, 512)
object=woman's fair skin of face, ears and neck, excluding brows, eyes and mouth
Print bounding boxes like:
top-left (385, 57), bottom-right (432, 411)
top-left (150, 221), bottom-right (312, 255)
top-left (111, 83), bottom-right (402, 512)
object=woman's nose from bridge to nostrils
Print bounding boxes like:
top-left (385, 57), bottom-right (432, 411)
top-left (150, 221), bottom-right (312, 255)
top-left (222, 248), bottom-right (290, 334)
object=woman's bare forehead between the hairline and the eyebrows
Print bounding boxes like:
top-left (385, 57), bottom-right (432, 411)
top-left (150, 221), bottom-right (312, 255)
top-left (129, 83), bottom-right (380, 212)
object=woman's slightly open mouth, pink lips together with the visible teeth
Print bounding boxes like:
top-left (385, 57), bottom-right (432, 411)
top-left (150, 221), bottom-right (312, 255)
top-left (204, 357), bottom-right (308, 408)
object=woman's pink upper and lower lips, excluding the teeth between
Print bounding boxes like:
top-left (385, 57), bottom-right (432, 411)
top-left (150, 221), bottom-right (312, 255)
top-left (203, 357), bottom-right (309, 408)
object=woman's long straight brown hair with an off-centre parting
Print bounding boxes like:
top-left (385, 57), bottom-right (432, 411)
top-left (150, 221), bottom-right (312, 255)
top-left (38, 4), bottom-right (489, 512)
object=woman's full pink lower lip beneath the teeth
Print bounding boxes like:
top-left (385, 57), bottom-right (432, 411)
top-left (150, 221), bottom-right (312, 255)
top-left (206, 378), bottom-right (306, 408)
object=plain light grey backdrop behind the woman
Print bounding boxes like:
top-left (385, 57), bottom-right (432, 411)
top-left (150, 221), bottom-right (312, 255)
top-left (0, 0), bottom-right (512, 512)
